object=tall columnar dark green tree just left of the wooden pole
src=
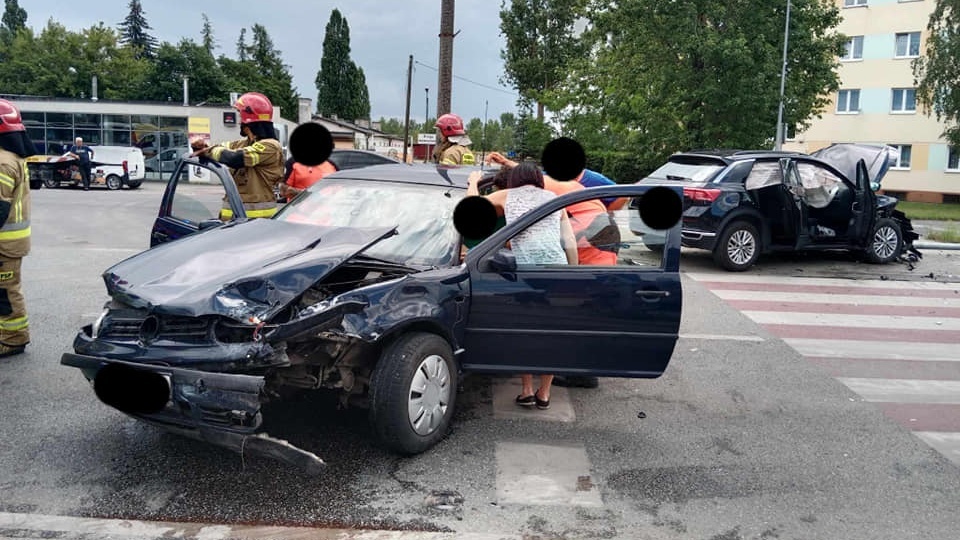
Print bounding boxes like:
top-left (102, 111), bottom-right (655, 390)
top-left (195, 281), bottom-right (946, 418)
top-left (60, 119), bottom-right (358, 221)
top-left (315, 9), bottom-right (370, 120)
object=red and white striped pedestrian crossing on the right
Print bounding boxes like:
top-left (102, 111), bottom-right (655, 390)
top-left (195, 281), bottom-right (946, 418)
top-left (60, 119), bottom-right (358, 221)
top-left (686, 273), bottom-right (960, 465)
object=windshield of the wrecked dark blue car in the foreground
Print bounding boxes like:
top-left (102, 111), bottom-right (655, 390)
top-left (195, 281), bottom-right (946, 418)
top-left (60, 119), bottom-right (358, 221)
top-left (274, 179), bottom-right (463, 266)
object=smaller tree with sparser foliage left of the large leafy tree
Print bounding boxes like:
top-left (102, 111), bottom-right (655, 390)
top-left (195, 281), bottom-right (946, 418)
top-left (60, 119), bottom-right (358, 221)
top-left (500, 0), bottom-right (587, 119)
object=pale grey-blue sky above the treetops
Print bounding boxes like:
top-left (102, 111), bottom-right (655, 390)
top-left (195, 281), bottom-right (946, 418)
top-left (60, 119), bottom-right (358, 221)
top-left (19, 0), bottom-right (517, 122)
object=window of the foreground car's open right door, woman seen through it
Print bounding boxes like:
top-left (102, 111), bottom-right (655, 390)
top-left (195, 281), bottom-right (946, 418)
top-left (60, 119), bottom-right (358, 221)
top-left (488, 193), bottom-right (669, 272)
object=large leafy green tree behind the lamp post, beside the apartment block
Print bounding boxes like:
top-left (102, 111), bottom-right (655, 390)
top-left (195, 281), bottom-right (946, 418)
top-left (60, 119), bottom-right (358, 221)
top-left (550, 0), bottom-right (846, 168)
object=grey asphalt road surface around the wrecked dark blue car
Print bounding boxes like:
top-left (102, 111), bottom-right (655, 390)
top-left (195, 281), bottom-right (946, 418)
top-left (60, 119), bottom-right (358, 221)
top-left (0, 183), bottom-right (960, 540)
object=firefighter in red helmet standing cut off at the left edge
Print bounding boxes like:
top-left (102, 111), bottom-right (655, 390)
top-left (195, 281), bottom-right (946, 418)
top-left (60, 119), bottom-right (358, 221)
top-left (0, 99), bottom-right (37, 357)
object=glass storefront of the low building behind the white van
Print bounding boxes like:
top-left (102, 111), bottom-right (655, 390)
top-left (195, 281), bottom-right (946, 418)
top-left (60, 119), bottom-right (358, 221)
top-left (21, 111), bottom-right (189, 178)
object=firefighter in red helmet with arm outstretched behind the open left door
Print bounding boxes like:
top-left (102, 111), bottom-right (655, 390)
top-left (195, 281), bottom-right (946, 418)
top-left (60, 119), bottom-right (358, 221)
top-left (190, 92), bottom-right (284, 221)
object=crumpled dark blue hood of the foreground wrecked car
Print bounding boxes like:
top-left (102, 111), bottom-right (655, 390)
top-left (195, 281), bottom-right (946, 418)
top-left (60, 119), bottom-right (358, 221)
top-left (103, 219), bottom-right (396, 321)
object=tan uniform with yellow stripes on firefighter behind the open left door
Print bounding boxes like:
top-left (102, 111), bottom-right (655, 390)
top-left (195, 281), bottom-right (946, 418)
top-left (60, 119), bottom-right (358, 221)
top-left (210, 139), bottom-right (283, 220)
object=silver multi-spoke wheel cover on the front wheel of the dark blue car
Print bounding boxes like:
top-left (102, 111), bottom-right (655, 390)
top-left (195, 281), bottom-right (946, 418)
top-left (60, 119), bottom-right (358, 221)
top-left (407, 354), bottom-right (453, 435)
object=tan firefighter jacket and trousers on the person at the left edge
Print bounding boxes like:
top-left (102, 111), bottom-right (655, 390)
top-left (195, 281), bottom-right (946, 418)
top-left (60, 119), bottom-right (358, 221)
top-left (0, 143), bottom-right (30, 356)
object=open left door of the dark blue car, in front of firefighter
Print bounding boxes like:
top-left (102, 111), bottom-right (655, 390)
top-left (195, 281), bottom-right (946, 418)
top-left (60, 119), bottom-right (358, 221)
top-left (150, 158), bottom-right (247, 247)
